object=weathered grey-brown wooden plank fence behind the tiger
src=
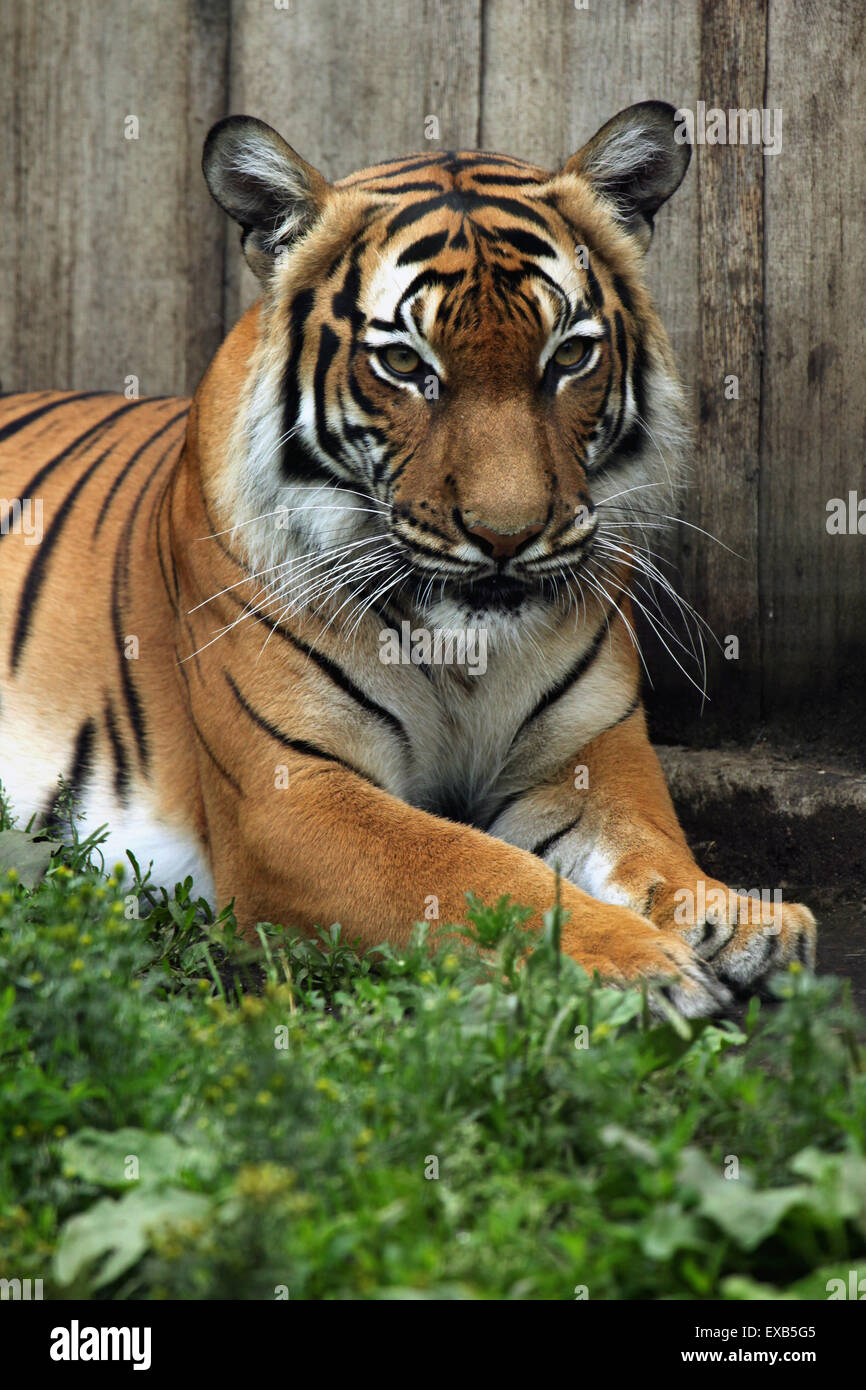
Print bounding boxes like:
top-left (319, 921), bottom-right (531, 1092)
top-left (0, 0), bottom-right (866, 728)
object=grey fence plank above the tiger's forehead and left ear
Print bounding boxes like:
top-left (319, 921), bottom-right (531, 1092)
top-left (227, 0), bottom-right (481, 321)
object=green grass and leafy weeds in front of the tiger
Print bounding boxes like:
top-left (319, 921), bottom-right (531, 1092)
top-left (0, 789), bottom-right (866, 1300)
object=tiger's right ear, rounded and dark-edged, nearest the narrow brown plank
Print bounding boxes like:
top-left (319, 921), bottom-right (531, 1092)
top-left (564, 101), bottom-right (692, 250)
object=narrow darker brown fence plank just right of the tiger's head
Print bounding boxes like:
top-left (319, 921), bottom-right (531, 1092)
top-left (695, 0), bottom-right (773, 734)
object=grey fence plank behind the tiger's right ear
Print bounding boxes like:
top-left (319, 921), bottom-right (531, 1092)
top-left (481, 0), bottom-right (709, 737)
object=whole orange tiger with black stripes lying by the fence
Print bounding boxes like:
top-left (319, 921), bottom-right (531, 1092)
top-left (0, 101), bottom-right (816, 1017)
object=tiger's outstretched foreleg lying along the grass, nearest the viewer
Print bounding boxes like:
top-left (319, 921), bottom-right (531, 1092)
top-left (206, 759), bottom-right (727, 1016)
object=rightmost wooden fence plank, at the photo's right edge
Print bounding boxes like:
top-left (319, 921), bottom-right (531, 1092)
top-left (760, 0), bottom-right (866, 711)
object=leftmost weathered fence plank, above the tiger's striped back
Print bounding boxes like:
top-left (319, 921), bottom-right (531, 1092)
top-left (0, 0), bottom-right (228, 395)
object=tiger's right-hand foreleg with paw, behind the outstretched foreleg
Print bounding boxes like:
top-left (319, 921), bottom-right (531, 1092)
top-left (500, 708), bottom-right (816, 988)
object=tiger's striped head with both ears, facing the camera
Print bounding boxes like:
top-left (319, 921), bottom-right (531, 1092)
top-left (200, 101), bottom-right (691, 630)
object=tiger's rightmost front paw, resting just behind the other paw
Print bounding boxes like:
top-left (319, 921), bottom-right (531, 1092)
top-left (649, 878), bottom-right (816, 990)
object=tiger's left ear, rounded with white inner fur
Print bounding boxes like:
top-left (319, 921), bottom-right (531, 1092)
top-left (202, 115), bottom-right (329, 281)
